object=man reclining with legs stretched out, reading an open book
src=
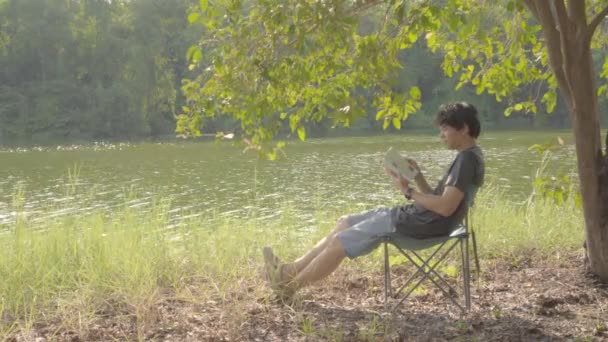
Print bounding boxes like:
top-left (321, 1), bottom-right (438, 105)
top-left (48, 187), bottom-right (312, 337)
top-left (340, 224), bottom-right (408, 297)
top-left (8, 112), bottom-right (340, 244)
top-left (264, 102), bottom-right (484, 296)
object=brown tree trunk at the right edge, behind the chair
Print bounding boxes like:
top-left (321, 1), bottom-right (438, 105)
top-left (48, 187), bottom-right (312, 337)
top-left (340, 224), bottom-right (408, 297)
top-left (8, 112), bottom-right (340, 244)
top-left (524, 0), bottom-right (608, 282)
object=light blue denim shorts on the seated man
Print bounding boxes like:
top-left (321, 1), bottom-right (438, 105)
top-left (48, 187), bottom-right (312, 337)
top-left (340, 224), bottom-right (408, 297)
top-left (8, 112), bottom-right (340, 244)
top-left (337, 208), bottom-right (395, 259)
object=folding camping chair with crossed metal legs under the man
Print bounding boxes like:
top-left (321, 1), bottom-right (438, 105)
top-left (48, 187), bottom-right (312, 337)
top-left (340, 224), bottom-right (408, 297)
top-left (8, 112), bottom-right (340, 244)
top-left (383, 214), bottom-right (480, 312)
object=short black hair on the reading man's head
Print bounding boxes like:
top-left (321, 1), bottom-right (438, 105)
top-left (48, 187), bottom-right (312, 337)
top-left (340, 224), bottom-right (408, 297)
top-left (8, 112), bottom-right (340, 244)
top-left (433, 102), bottom-right (481, 138)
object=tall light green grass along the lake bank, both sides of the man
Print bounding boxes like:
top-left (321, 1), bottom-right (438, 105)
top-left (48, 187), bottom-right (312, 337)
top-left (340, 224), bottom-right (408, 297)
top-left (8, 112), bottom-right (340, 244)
top-left (0, 187), bottom-right (584, 339)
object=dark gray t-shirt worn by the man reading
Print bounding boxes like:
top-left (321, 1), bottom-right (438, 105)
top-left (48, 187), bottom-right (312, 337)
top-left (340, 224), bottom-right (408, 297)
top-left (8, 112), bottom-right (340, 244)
top-left (392, 145), bottom-right (485, 239)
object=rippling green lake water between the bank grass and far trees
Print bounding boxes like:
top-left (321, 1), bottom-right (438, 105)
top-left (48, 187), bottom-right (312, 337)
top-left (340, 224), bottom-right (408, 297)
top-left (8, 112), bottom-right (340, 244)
top-left (0, 131), bottom-right (575, 225)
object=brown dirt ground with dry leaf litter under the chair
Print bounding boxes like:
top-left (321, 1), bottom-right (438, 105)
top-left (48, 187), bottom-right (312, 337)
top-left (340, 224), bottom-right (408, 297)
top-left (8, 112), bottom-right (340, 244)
top-left (8, 253), bottom-right (608, 342)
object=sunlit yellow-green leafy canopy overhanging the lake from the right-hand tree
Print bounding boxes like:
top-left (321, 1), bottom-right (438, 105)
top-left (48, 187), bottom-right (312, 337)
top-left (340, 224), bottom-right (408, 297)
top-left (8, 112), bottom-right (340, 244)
top-left (177, 0), bottom-right (608, 158)
